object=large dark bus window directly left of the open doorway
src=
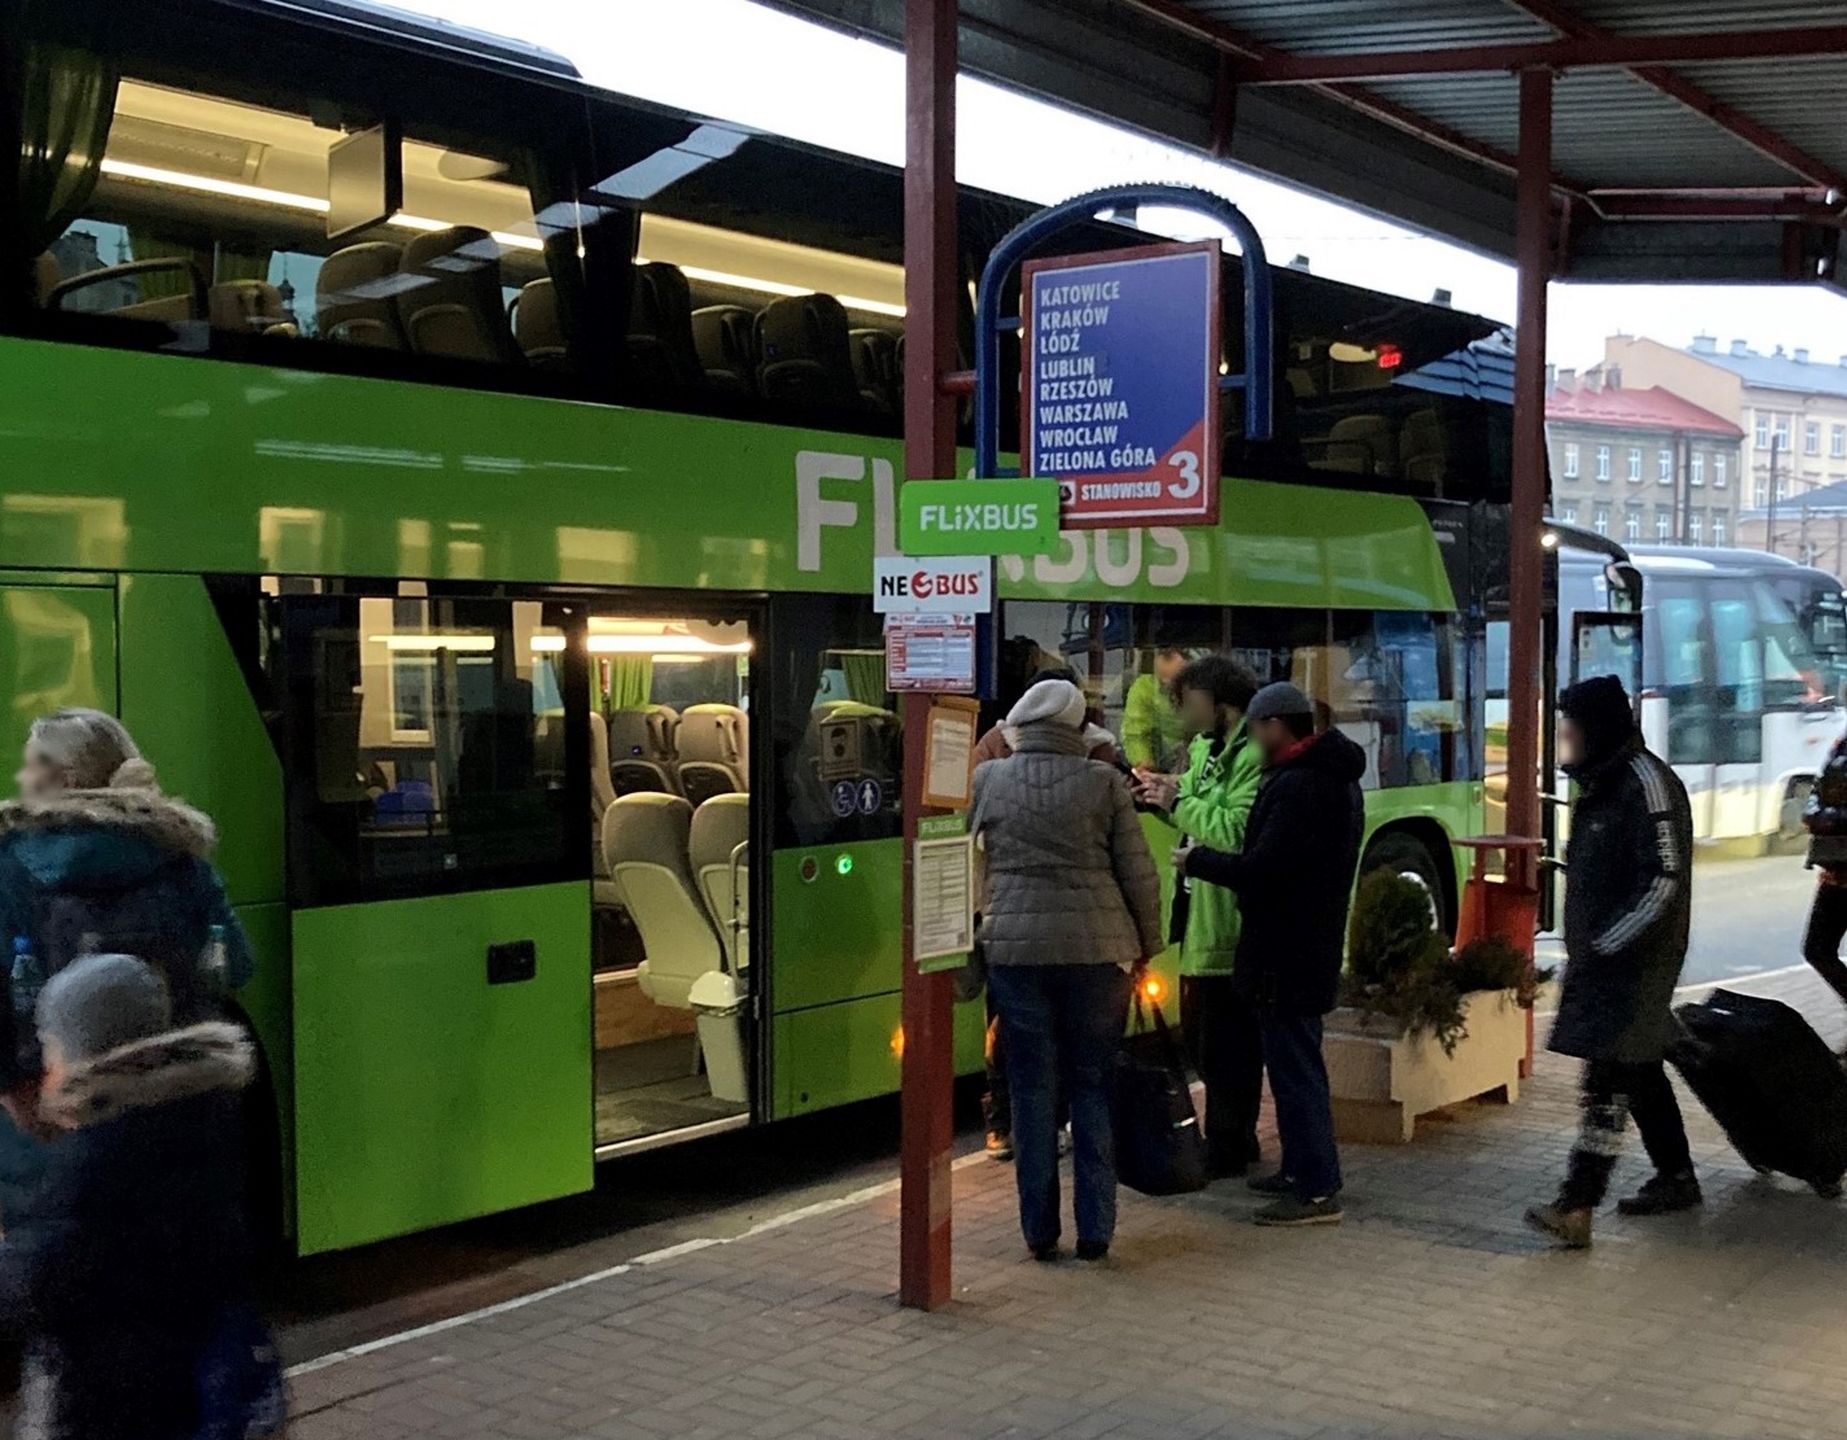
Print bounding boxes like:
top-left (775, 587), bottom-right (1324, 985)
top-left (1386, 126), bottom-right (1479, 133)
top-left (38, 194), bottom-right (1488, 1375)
top-left (283, 596), bottom-right (587, 905)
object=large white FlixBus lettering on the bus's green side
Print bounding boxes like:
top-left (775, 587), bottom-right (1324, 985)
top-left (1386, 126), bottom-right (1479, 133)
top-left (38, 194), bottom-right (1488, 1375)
top-left (796, 450), bottom-right (1191, 591)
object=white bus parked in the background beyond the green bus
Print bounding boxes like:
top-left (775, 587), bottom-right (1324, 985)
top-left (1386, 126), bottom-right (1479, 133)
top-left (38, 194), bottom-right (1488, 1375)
top-left (1559, 539), bottom-right (1847, 851)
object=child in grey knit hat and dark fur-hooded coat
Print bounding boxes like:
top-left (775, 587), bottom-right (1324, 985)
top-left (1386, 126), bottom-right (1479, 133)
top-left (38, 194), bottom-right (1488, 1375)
top-left (0, 954), bottom-right (255, 1440)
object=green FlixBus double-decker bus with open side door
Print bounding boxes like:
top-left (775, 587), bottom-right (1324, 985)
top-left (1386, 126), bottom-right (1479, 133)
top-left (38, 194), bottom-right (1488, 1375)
top-left (0, 0), bottom-right (1507, 1254)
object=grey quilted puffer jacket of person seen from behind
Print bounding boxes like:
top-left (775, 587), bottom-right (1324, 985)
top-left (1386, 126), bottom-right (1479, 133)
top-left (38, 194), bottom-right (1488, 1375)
top-left (973, 722), bottom-right (1165, 966)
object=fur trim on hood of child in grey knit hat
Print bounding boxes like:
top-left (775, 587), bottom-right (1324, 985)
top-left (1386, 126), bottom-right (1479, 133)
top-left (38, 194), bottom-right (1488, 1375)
top-left (41, 1021), bottom-right (257, 1130)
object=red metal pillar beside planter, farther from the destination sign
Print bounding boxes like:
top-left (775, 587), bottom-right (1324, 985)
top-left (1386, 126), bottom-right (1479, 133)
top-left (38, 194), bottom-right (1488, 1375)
top-left (1507, 70), bottom-right (1553, 884)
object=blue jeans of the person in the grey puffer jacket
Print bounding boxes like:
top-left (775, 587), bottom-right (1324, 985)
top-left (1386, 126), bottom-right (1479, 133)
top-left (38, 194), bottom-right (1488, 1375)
top-left (988, 964), bottom-right (1129, 1248)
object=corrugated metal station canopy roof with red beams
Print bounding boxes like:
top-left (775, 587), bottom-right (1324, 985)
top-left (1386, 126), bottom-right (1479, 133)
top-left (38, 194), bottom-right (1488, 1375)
top-left (772, 0), bottom-right (1847, 284)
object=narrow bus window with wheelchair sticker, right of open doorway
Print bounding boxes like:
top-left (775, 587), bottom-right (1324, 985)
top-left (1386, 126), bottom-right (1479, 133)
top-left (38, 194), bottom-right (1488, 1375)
top-left (770, 596), bottom-right (903, 846)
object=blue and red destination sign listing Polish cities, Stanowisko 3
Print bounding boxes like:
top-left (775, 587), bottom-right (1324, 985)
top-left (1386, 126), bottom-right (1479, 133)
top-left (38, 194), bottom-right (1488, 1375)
top-left (1020, 240), bottom-right (1221, 530)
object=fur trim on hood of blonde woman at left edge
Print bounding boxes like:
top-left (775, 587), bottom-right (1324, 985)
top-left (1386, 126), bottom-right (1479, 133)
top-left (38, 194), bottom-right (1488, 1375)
top-left (0, 786), bottom-right (218, 886)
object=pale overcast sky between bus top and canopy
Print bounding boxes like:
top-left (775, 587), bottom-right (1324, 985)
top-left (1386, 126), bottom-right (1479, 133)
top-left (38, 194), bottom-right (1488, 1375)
top-left (393, 0), bottom-right (1847, 369)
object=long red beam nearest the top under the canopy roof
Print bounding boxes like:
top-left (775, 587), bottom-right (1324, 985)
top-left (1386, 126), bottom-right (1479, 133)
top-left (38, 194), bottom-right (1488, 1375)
top-left (1226, 26), bottom-right (1847, 85)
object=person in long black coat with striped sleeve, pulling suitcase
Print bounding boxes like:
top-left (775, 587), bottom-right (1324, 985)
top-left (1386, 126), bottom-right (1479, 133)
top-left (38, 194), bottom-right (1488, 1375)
top-left (1526, 676), bottom-right (1701, 1248)
